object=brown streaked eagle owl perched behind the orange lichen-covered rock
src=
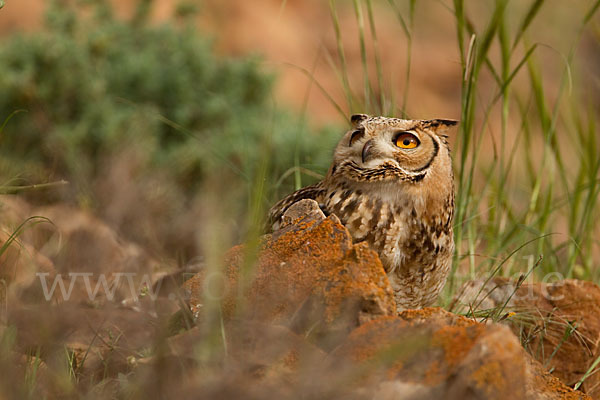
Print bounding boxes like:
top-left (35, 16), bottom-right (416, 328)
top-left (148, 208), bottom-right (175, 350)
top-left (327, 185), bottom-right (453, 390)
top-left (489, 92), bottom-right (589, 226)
top-left (269, 114), bottom-right (456, 311)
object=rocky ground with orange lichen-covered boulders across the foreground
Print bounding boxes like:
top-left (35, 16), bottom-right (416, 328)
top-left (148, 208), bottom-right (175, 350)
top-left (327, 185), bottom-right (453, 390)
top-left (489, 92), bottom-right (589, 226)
top-left (0, 197), bottom-right (600, 399)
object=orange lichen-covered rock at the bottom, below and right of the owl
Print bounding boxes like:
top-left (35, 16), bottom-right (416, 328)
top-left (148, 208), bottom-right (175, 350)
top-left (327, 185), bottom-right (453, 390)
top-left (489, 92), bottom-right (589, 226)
top-left (333, 308), bottom-right (587, 400)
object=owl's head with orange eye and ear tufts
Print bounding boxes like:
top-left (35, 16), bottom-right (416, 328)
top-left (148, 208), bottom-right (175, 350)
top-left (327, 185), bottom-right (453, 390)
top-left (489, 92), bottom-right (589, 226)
top-left (330, 114), bottom-right (457, 183)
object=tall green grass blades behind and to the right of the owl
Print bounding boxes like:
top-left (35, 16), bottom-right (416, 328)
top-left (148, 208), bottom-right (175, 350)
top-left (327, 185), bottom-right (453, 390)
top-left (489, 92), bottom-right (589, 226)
top-left (330, 0), bottom-right (600, 303)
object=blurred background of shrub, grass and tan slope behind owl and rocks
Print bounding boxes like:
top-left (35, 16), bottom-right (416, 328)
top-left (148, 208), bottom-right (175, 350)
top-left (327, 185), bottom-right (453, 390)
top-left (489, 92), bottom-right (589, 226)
top-left (0, 0), bottom-right (600, 299)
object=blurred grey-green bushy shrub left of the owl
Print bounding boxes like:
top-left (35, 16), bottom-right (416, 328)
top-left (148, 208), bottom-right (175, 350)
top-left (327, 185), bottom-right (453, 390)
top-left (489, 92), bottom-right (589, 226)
top-left (0, 1), bottom-right (332, 255)
